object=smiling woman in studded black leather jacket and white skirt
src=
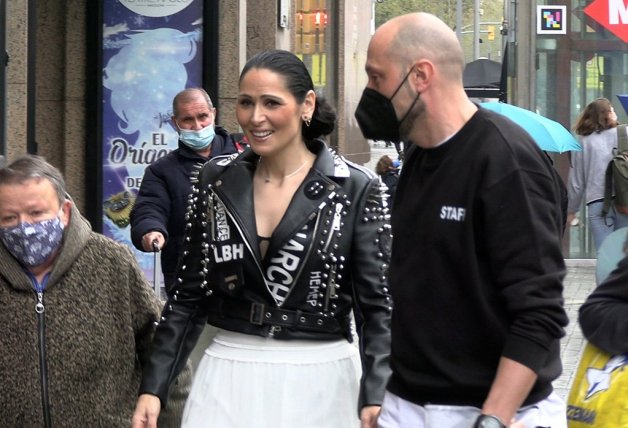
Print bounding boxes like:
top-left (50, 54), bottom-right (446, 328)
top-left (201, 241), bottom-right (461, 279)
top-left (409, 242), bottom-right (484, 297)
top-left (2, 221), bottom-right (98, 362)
top-left (133, 50), bottom-right (392, 428)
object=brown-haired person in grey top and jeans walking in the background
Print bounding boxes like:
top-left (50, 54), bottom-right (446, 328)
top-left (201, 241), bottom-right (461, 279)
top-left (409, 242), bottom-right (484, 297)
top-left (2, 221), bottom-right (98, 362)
top-left (567, 98), bottom-right (628, 250)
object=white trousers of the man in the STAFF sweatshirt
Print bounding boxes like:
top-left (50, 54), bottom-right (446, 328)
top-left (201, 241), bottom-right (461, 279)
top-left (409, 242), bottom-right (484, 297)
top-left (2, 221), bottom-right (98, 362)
top-left (378, 391), bottom-right (567, 428)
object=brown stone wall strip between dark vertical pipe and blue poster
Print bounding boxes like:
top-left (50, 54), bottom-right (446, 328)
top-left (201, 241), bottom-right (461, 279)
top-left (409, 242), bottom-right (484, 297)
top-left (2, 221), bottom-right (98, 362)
top-left (35, 0), bottom-right (87, 207)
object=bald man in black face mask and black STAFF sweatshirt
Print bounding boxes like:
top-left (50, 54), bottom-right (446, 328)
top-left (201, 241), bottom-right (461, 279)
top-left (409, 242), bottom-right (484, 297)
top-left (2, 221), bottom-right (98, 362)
top-left (356, 13), bottom-right (568, 428)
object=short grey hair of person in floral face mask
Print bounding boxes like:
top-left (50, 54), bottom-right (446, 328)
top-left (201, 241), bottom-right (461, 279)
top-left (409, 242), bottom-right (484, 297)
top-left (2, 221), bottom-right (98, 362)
top-left (0, 155), bottom-right (69, 205)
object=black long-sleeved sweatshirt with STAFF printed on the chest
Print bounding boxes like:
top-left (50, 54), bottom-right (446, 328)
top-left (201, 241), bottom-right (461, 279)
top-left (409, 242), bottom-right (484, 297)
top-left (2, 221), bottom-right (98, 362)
top-left (388, 108), bottom-right (568, 407)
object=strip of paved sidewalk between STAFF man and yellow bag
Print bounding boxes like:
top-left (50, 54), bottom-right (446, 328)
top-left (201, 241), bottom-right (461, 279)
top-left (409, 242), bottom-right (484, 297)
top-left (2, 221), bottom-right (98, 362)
top-left (554, 259), bottom-right (596, 400)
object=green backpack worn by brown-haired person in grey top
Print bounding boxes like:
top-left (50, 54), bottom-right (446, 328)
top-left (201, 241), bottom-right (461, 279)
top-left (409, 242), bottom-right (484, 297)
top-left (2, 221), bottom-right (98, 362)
top-left (602, 125), bottom-right (628, 217)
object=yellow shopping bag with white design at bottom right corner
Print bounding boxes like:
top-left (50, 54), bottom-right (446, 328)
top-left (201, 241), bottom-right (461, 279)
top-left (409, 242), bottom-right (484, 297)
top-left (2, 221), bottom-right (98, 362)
top-left (567, 343), bottom-right (628, 428)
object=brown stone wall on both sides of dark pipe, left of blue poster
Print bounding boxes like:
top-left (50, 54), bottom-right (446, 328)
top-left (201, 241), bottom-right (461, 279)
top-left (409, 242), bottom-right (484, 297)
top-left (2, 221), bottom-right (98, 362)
top-left (6, 0), bottom-right (87, 208)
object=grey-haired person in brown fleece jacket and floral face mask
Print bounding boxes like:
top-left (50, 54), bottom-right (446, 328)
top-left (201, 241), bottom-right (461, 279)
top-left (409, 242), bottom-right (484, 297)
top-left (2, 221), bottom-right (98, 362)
top-left (0, 155), bottom-right (191, 428)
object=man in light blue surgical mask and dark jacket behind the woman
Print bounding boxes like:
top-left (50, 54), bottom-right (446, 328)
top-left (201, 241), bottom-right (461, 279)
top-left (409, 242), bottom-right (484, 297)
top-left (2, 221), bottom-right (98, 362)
top-left (131, 88), bottom-right (241, 290)
